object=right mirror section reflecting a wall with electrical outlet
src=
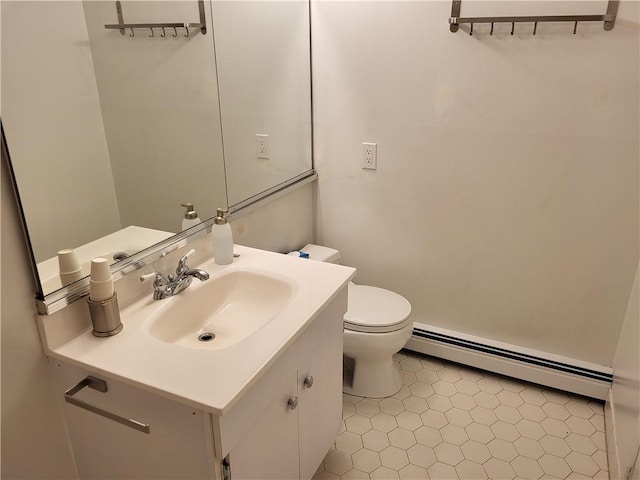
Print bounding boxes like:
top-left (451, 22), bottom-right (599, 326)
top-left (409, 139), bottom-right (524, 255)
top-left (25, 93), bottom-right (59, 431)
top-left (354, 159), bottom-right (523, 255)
top-left (212, 1), bottom-right (312, 207)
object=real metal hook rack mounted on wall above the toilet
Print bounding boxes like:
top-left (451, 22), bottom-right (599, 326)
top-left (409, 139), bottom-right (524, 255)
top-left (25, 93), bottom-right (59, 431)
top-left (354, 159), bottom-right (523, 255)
top-left (449, 0), bottom-right (620, 35)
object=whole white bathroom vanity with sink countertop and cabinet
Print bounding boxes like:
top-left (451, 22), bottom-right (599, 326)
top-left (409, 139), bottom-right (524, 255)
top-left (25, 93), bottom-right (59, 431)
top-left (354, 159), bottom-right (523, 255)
top-left (38, 246), bottom-right (355, 479)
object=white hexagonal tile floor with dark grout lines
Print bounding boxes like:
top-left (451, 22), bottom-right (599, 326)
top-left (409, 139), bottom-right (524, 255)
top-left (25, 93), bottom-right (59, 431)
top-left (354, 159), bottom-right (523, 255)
top-left (314, 351), bottom-right (609, 480)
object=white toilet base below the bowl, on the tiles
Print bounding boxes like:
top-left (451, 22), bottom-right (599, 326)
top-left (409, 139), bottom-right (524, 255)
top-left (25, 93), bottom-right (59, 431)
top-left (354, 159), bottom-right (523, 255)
top-left (342, 357), bottom-right (402, 398)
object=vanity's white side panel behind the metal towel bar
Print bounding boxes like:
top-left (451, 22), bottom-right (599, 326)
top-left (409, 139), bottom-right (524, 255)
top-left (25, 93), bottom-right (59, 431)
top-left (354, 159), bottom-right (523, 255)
top-left (52, 361), bottom-right (215, 479)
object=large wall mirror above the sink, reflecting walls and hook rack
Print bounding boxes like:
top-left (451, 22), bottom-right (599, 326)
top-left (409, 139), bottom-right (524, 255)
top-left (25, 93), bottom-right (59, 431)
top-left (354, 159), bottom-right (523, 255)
top-left (1, 0), bottom-right (313, 302)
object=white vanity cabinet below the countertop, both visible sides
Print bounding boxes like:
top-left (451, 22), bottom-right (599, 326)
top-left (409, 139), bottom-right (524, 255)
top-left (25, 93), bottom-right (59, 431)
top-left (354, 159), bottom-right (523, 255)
top-left (51, 289), bottom-right (347, 480)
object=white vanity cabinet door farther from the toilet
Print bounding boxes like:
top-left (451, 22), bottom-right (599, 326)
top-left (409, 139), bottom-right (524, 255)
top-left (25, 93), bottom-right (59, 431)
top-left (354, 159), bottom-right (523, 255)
top-left (229, 373), bottom-right (299, 480)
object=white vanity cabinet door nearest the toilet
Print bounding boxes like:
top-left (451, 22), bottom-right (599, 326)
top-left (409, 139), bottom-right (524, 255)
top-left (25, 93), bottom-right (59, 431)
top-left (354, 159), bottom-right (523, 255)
top-left (298, 289), bottom-right (346, 479)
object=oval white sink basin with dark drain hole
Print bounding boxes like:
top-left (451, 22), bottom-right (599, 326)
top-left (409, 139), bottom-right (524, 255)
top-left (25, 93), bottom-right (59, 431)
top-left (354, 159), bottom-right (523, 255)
top-left (146, 270), bottom-right (295, 350)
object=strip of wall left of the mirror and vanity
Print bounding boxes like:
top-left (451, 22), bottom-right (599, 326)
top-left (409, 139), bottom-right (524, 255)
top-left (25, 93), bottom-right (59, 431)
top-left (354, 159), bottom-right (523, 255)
top-left (0, 152), bottom-right (76, 480)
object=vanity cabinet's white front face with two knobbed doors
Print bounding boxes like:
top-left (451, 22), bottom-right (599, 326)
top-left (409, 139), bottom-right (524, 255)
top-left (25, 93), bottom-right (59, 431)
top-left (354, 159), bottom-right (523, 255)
top-left (226, 294), bottom-right (346, 480)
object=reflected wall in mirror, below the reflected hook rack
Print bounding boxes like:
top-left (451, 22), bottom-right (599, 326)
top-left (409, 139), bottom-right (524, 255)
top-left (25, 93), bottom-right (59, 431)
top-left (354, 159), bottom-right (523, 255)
top-left (83, 1), bottom-right (227, 232)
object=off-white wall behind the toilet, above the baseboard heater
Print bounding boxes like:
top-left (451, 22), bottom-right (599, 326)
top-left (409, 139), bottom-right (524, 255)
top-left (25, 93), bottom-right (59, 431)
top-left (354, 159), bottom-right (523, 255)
top-left (312, 1), bottom-right (640, 366)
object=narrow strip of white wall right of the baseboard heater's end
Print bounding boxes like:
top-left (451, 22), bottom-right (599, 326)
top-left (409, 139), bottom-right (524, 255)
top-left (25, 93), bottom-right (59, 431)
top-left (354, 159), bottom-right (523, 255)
top-left (605, 265), bottom-right (640, 479)
